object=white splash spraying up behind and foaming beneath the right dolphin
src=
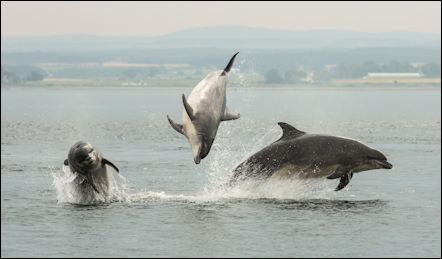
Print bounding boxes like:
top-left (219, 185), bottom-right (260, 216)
top-left (115, 123), bottom-right (344, 206)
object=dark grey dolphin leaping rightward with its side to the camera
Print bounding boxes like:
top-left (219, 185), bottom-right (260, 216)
top-left (230, 122), bottom-right (393, 191)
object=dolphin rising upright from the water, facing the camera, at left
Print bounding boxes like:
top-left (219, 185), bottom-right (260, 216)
top-left (64, 141), bottom-right (119, 195)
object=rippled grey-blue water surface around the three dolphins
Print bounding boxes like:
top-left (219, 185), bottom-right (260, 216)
top-left (1, 86), bottom-right (441, 257)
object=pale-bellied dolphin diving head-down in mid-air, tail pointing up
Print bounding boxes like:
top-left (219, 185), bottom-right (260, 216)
top-left (167, 52), bottom-right (240, 164)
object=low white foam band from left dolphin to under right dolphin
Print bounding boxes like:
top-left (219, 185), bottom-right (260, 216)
top-left (52, 166), bottom-right (342, 205)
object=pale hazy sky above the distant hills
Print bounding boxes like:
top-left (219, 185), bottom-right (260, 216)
top-left (1, 1), bottom-right (441, 37)
